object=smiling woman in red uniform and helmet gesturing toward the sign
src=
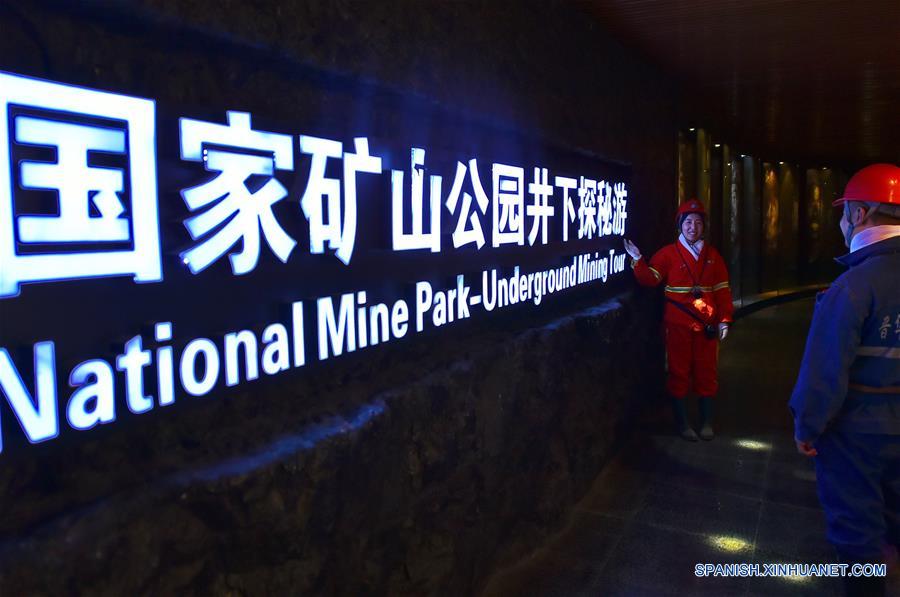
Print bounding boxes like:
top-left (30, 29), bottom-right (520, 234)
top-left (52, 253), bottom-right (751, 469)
top-left (625, 199), bottom-right (733, 441)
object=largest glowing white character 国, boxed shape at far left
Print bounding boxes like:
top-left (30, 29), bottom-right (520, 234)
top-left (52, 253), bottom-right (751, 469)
top-left (0, 73), bottom-right (162, 297)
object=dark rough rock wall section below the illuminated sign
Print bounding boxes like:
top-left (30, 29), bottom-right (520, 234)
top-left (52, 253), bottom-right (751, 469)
top-left (0, 300), bottom-right (660, 595)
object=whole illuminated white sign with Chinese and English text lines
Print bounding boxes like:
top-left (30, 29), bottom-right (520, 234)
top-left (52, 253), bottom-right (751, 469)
top-left (0, 73), bottom-right (629, 450)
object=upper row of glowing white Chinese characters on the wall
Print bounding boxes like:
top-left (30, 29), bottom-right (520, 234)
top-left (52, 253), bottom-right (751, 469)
top-left (0, 67), bottom-right (628, 298)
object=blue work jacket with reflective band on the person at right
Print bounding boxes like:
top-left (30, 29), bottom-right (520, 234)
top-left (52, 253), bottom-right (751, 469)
top-left (790, 236), bottom-right (900, 442)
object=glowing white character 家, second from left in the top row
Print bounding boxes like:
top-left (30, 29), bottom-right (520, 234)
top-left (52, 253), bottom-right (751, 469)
top-left (180, 112), bottom-right (297, 275)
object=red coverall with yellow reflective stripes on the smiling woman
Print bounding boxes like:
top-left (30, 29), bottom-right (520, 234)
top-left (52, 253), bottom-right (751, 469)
top-left (632, 241), bottom-right (734, 398)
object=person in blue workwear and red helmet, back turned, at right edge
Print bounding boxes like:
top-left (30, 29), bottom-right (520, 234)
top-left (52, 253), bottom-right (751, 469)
top-left (790, 164), bottom-right (900, 595)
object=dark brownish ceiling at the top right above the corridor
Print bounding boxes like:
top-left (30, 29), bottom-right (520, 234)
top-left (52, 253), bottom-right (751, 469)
top-left (585, 0), bottom-right (900, 165)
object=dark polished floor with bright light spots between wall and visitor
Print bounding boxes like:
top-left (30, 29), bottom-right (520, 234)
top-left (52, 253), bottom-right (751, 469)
top-left (484, 299), bottom-right (900, 597)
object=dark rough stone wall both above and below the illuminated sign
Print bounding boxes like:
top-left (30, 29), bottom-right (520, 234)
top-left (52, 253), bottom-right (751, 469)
top-left (0, 0), bottom-right (677, 595)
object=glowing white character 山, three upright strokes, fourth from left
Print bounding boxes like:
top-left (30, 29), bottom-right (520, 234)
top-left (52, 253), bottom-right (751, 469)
top-left (391, 148), bottom-right (442, 253)
